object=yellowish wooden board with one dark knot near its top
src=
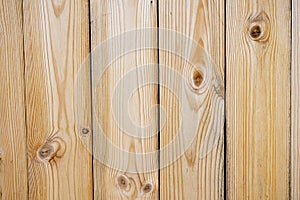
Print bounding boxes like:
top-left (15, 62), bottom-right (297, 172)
top-left (226, 0), bottom-right (291, 199)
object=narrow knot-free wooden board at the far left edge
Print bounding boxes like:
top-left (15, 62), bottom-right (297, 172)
top-left (0, 0), bottom-right (27, 199)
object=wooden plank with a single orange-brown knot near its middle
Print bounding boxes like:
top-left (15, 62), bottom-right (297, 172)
top-left (159, 0), bottom-right (224, 199)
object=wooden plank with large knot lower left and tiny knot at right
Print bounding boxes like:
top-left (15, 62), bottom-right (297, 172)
top-left (23, 0), bottom-right (93, 199)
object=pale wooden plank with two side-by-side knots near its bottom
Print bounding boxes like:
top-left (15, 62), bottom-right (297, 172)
top-left (91, 0), bottom-right (158, 199)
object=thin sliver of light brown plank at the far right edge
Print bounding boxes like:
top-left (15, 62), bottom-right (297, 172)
top-left (290, 0), bottom-right (300, 199)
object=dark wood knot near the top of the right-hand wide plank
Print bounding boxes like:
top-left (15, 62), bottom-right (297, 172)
top-left (248, 12), bottom-right (270, 42)
